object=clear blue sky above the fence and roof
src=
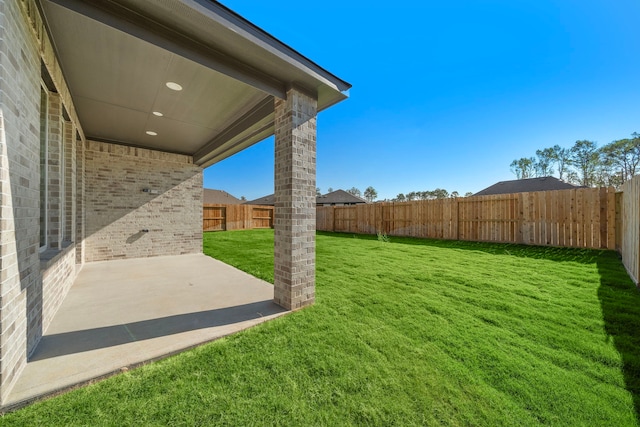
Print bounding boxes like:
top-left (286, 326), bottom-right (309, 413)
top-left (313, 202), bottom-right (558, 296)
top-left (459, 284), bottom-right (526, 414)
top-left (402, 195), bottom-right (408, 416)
top-left (204, 0), bottom-right (640, 199)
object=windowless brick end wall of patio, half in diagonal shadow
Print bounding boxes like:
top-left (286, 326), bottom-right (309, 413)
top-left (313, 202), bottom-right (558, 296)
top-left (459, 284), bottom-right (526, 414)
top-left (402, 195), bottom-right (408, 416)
top-left (85, 141), bottom-right (202, 262)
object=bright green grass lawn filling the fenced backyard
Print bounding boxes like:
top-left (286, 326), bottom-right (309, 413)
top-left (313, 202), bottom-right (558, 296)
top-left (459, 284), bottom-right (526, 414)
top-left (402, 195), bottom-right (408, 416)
top-left (0, 230), bottom-right (640, 426)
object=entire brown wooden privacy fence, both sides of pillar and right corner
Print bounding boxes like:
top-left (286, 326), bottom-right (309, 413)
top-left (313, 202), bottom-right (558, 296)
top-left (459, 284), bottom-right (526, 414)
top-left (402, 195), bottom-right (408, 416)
top-left (203, 182), bottom-right (640, 284)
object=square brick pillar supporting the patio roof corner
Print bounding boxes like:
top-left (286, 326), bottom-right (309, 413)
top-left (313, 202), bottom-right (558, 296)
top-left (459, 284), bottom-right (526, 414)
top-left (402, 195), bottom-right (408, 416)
top-left (273, 88), bottom-right (317, 310)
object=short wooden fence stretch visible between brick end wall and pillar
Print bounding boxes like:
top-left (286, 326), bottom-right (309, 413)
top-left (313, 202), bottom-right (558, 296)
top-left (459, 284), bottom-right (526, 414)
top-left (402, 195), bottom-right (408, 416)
top-left (202, 204), bottom-right (273, 231)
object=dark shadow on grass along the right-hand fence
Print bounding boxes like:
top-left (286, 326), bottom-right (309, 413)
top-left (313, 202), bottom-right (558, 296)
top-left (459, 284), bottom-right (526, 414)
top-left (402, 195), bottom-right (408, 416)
top-left (597, 253), bottom-right (640, 421)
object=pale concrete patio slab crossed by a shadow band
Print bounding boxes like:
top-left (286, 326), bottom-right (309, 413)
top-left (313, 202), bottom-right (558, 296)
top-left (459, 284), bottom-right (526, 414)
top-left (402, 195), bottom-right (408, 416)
top-left (5, 254), bottom-right (286, 408)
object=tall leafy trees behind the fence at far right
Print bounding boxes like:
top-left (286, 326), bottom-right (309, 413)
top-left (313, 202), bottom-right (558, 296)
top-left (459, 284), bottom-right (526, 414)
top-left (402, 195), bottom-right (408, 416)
top-left (511, 132), bottom-right (640, 187)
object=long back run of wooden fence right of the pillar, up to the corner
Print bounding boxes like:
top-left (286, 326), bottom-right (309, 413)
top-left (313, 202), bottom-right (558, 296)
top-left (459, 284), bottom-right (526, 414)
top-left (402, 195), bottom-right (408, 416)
top-left (316, 185), bottom-right (620, 249)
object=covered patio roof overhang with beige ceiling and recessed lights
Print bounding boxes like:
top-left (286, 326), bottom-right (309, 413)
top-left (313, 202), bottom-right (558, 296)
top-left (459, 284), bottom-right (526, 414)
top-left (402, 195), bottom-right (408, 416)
top-left (41, 0), bottom-right (351, 167)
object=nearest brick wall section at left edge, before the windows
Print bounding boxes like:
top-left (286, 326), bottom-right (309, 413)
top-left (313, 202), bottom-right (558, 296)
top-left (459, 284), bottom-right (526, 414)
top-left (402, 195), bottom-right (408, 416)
top-left (0, 2), bottom-right (42, 399)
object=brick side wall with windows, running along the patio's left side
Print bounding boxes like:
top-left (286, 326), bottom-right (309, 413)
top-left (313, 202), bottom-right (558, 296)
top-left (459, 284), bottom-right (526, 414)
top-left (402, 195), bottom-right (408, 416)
top-left (0, 1), bottom-right (82, 401)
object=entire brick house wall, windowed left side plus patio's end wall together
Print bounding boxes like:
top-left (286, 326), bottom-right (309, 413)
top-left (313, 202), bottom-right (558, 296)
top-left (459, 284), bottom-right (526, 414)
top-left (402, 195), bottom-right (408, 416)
top-left (0, 0), bottom-right (202, 405)
